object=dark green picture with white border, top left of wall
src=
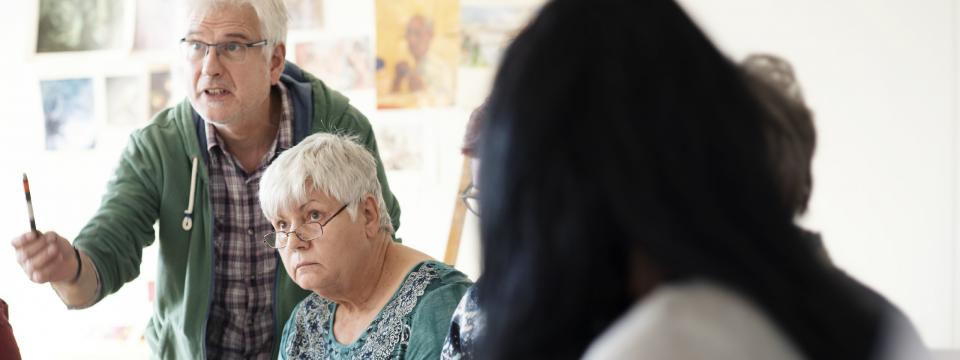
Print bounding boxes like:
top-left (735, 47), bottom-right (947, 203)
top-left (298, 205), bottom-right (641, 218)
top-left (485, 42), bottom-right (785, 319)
top-left (37, 0), bottom-right (133, 53)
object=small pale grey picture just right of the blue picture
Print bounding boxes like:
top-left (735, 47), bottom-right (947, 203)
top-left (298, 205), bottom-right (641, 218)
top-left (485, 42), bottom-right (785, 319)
top-left (106, 76), bottom-right (152, 127)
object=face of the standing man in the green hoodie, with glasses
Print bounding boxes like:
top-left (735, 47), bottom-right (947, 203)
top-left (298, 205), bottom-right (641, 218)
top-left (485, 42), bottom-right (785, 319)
top-left (184, 5), bottom-right (284, 125)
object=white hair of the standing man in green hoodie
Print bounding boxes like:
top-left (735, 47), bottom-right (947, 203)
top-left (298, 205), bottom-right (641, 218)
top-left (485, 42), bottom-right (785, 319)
top-left (186, 0), bottom-right (289, 59)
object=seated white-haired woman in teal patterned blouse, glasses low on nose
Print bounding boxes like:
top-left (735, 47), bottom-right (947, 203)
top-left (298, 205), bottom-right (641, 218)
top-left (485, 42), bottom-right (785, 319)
top-left (260, 134), bottom-right (471, 359)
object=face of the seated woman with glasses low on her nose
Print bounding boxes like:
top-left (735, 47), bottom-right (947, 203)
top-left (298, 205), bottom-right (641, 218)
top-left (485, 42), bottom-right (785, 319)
top-left (273, 190), bottom-right (373, 296)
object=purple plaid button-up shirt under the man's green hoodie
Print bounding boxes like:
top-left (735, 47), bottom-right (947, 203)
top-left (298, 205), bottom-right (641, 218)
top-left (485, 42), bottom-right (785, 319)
top-left (207, 83), bottom-right (293, 359)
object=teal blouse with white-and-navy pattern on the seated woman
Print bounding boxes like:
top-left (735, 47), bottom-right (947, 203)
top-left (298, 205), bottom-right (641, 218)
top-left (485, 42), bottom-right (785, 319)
top-left (280, 260), bottom-right (471, 360)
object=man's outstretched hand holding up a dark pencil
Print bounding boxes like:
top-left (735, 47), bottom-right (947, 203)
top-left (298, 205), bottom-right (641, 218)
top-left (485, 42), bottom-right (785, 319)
top-left (11, 231), bottom-right (79, 284)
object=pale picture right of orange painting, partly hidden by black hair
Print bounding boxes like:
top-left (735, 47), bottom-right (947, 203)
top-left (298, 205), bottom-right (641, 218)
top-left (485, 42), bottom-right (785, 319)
top-left (460, 5), bottom-right (538, 67)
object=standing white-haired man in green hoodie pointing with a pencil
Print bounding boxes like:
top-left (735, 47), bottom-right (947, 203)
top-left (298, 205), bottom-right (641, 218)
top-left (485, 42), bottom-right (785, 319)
top-left (13, 0), bottom-right (400, 359)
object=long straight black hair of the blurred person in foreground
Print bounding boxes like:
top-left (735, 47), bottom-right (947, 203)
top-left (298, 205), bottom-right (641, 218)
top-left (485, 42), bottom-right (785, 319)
top-left (478, 0), bottom-right (878, 359)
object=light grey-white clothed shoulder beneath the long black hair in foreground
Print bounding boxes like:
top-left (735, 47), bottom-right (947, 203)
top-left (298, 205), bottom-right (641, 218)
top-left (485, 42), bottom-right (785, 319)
top-left (585, 281), bottom-right (801, 359)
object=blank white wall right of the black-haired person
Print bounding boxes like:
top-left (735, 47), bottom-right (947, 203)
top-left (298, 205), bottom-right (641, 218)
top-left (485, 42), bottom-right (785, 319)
top-left (681, 0), bottom-right (960, 348)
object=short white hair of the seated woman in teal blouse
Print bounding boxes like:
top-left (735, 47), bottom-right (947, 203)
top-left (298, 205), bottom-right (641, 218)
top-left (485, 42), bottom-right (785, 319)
top-left (260, 133), bottom-right (393, 234)
